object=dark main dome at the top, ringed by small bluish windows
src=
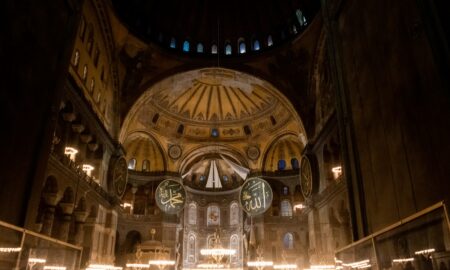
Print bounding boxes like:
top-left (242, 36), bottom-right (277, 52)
top-left (112, 0), bottom-right (320, 56)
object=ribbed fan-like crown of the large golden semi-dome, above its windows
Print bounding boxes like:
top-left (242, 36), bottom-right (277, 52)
top-left (150, 69), bottom-right (277, 124)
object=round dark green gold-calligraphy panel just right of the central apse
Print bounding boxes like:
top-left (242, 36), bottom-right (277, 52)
top-left (239, 177), bottom-right (273, 216)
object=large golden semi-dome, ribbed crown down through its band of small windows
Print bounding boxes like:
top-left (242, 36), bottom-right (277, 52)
top-left (124, 68), bottom-right (303, 140)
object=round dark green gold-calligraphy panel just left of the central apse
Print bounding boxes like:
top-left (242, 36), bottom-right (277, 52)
top-left (155, 179), bottom-right (186, 214)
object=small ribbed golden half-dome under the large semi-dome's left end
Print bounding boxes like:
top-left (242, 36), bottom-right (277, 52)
top-left (123, 132), bottom-right (165, 172)
